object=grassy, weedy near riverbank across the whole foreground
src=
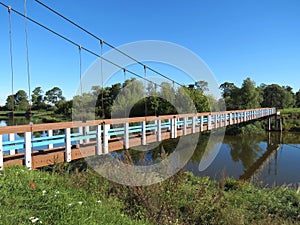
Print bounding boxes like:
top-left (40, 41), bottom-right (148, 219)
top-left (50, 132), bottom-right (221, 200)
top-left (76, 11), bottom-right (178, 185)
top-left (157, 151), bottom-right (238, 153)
top-left (0, 161), bottom-right (300, 225)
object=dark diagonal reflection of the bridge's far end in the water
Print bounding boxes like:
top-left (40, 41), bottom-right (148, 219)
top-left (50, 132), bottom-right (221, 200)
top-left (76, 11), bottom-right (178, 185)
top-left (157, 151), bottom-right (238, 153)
top-left (239, 133), bottom-right (280, 180)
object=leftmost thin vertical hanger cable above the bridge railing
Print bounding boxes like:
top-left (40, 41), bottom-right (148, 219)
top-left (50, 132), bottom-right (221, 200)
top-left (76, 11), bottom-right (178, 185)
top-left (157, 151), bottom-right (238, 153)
top-left (7, 6), bottom-right (15, 125)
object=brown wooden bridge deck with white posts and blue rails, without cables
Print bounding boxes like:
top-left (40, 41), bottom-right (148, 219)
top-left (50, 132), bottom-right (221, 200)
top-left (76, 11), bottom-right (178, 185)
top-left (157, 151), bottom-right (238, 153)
top-left (0, 108), bottom-right (276, 169)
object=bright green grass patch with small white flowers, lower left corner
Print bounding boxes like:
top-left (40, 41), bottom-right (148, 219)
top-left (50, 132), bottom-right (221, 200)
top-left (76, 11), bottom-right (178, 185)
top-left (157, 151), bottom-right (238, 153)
top-left (0, 167), bottom-right (150, 225)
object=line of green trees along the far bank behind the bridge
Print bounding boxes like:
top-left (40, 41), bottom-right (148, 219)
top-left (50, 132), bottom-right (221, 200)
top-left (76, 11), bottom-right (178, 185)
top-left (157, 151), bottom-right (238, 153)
top-left (1, 78), bottom-right (300, 119)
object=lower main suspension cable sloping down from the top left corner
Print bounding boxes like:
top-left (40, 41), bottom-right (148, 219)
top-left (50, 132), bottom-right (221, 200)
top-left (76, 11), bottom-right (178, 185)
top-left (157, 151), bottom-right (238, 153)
top-left (0, 2), bottom-right (161, 90)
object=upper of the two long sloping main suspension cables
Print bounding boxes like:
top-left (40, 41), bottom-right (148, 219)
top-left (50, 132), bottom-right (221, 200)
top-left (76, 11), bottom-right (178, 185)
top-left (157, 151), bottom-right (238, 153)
top-left (35, 0), bottom-right (184, 87)
